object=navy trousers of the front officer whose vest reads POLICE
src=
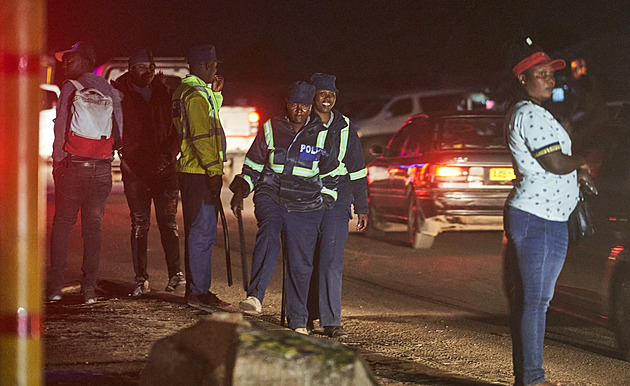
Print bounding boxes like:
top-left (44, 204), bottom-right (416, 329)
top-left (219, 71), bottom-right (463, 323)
top-left (247, 194), bottom-right (323, 329)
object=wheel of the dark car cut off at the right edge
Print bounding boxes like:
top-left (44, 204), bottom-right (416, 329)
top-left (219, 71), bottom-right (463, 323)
top-left (612, 272), bottom-right (630, 361)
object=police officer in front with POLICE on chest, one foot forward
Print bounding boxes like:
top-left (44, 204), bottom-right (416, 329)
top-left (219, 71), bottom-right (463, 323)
top-left (230, 82), bottom-right (337, 334)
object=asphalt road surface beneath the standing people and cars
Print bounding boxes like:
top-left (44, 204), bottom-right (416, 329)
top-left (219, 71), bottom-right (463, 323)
top-left (46, 176), bottom-right (630, 385)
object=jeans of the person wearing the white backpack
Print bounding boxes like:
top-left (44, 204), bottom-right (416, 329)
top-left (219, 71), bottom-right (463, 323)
top-left (48, 157), bottom-right (112, 294)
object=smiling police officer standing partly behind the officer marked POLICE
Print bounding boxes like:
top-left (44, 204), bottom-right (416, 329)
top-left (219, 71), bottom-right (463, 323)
top-left (308, 73), bottom-right (368, 338)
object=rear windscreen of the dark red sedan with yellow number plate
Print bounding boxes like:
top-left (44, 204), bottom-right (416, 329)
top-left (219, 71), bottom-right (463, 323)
top-left (439, 117), bottom-right (506, 150)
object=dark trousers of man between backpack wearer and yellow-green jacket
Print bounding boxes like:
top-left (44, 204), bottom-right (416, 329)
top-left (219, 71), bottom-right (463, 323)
top-left (122, 168), bottom-right (181, 281)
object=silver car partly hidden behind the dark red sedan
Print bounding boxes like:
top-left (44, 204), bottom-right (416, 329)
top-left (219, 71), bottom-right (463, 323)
top-left (340, 88), bottom-right (488, 162)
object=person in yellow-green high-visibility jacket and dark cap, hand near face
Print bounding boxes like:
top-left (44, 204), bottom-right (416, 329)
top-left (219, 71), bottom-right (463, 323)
top-left (173, 44), bottom-right (229, 307)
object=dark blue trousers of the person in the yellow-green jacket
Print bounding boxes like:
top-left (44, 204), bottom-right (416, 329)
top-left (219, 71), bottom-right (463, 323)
top-left (178, 173), bottom-right (217, 295)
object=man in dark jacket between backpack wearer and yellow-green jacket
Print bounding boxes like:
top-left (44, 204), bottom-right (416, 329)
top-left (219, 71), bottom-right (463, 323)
top-left (114, 50), bottom-right (186, 297)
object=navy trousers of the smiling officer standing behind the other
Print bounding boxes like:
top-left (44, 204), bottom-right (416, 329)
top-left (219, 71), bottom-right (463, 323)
top-left (308, 197), bottom-right (352, 326)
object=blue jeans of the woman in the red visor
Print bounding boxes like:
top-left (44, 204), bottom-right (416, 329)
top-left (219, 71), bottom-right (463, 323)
top-left (505, 206), bottom-right (569, 385)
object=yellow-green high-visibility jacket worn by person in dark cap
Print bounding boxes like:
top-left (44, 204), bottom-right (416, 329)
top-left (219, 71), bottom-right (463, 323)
top-left (172, 75), bottom-right (225, 176)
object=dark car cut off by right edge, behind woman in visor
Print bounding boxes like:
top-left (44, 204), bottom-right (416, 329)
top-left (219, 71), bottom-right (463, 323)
top-left (552, 120), bottom-right (630, 360)
